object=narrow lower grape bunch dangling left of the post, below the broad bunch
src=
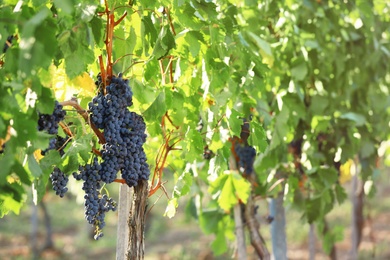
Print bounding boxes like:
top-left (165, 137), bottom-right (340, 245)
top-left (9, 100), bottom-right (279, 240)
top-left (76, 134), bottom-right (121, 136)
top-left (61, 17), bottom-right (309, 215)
top-left (73, 157), bottom-right (116, 239)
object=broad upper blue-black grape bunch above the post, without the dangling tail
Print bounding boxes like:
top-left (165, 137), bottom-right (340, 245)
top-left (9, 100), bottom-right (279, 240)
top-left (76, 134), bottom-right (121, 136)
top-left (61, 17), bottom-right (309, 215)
top-left (89, 76), bottom-right (149, 187)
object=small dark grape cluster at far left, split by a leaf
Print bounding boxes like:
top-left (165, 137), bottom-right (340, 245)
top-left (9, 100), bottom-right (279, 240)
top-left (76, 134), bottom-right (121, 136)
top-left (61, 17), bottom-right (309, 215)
top-left (38, 100), bottom-right (67, 155)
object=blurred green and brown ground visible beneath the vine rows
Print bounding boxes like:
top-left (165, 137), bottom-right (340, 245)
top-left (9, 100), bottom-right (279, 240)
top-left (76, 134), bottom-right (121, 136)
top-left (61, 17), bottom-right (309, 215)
top-left (0, 175), bottom-right (390, 260)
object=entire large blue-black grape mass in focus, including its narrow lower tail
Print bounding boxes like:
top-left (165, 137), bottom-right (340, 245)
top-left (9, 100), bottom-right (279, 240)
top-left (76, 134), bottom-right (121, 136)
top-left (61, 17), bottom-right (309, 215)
top-left (73, 75), bottom-right (149, 239)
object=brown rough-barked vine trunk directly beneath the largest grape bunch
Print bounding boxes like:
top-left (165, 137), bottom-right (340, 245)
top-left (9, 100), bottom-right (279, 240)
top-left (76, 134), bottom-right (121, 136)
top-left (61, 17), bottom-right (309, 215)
top-left (126, 180), bottom-right (148, 260)
